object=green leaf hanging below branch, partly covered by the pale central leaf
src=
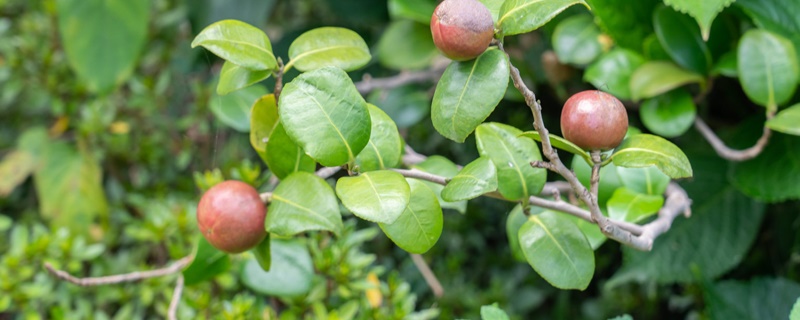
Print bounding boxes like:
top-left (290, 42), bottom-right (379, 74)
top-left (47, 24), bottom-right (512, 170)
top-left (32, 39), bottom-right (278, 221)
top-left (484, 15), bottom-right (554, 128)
top-left (378, 179), bottom-right (444, 254)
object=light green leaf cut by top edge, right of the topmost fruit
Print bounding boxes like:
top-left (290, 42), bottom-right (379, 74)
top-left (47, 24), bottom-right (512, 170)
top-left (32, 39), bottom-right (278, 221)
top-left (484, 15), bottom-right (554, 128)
top-left (497, 0), bottom-right (589, 36)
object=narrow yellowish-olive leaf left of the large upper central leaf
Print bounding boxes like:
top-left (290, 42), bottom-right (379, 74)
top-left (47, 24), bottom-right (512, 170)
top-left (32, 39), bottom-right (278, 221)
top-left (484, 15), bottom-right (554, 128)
top-left (250, 94), bottom-right (279, 157)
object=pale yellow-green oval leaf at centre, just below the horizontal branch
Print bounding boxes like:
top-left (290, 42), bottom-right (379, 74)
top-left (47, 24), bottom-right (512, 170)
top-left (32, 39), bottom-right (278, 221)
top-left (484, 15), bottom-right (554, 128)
top-left (336, 170), bottom-right (411, 224)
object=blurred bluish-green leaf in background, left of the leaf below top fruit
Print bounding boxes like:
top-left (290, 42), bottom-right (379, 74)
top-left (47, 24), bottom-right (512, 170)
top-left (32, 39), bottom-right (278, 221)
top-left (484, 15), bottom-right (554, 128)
top-left (367, 86), bottom-right (431, 128)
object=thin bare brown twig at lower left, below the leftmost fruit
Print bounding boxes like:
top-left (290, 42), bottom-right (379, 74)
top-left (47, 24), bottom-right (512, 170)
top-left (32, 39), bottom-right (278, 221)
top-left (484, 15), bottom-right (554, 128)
top-left (44, 256), bottom-right (193, 287)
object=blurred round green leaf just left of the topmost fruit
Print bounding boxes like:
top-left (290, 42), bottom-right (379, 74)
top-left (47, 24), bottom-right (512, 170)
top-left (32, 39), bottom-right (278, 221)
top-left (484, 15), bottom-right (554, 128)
top-left (377, 20), bottom-right (439, 70)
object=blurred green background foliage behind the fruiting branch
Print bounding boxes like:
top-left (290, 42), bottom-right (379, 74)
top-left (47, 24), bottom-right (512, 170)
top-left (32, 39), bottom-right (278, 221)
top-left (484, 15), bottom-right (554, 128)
top-left (0, 0), bottom-right (800, 319)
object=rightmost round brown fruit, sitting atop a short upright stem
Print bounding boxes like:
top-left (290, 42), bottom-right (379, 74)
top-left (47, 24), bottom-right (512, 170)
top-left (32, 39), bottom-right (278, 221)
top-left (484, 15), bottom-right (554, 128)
top-left (561, 90), bottom-right (628, 151)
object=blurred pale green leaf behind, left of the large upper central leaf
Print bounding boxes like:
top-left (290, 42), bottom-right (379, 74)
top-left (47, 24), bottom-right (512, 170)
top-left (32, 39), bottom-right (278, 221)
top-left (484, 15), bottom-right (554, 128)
top-left (208, 86), bottom-right (267, 132)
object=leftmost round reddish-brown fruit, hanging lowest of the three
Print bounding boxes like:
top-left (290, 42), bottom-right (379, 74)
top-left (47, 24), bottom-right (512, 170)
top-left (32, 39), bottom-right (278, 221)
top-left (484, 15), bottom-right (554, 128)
top-left (197, 180), bottom-right (267, 253)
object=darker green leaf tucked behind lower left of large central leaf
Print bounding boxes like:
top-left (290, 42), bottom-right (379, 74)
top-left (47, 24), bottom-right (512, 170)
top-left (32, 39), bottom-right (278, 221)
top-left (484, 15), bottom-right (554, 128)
top-left (265, 122), bottom-right (317, 179)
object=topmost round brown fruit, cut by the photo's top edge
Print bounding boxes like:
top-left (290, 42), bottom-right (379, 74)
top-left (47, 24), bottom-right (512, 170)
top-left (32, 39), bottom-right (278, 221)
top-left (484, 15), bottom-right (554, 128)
top-left (431, 0), bottom-right (494, 61)
